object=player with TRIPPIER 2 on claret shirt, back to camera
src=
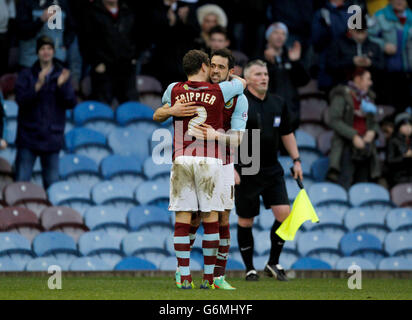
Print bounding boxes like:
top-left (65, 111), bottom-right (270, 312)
top-left (153, 50), bottom-right (246, 289)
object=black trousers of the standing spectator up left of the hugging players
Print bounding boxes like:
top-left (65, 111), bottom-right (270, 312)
top-left (90, 64), bottom-right (139, 105)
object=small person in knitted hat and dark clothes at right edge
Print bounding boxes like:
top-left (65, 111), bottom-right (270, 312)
top-left (386, 112), bottom-right (412, 187)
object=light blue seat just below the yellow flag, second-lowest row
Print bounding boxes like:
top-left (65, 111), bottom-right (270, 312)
top-left (297, 231), bottom-right (342, 266)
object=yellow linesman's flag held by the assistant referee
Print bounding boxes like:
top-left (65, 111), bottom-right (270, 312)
top-left (276, 189), bottom-right (319, 240)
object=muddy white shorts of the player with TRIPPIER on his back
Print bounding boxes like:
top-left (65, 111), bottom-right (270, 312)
top-left (169, 156), bottom-right (224, 212)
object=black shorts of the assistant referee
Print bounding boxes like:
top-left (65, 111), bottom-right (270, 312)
top-left (235, 162), bottom-right (290, 218)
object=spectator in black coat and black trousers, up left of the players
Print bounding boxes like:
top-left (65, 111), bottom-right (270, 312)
top-left (84, 0), bottom-right (138, 104)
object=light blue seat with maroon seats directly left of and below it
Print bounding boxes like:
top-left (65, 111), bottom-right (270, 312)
top-left (47, 181), bottom-right (93, 215)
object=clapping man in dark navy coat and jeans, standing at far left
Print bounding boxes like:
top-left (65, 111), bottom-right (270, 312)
top-left (15, 36), bottom-right (76, 189)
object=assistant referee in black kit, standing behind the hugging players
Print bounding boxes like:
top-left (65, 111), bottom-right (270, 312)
top-left (235, 60), bottom-right (303, 281)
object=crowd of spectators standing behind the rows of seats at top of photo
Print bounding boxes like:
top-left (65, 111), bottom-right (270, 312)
top-left (0, 0), bottom-right (412, 191)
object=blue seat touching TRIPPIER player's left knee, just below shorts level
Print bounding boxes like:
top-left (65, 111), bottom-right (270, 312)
top-left (127, 205), bottom-right (173, 231)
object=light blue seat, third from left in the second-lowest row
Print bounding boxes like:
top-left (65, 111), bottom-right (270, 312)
top-left (78, 231), bottom-right (124, 268)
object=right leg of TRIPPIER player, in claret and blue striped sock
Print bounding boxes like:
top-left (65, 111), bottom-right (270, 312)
top-left (200, 211), bottom-right (219, 289)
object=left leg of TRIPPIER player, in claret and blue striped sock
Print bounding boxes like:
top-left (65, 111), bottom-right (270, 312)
top-left (173, 211), bottom-right (193, 289)
